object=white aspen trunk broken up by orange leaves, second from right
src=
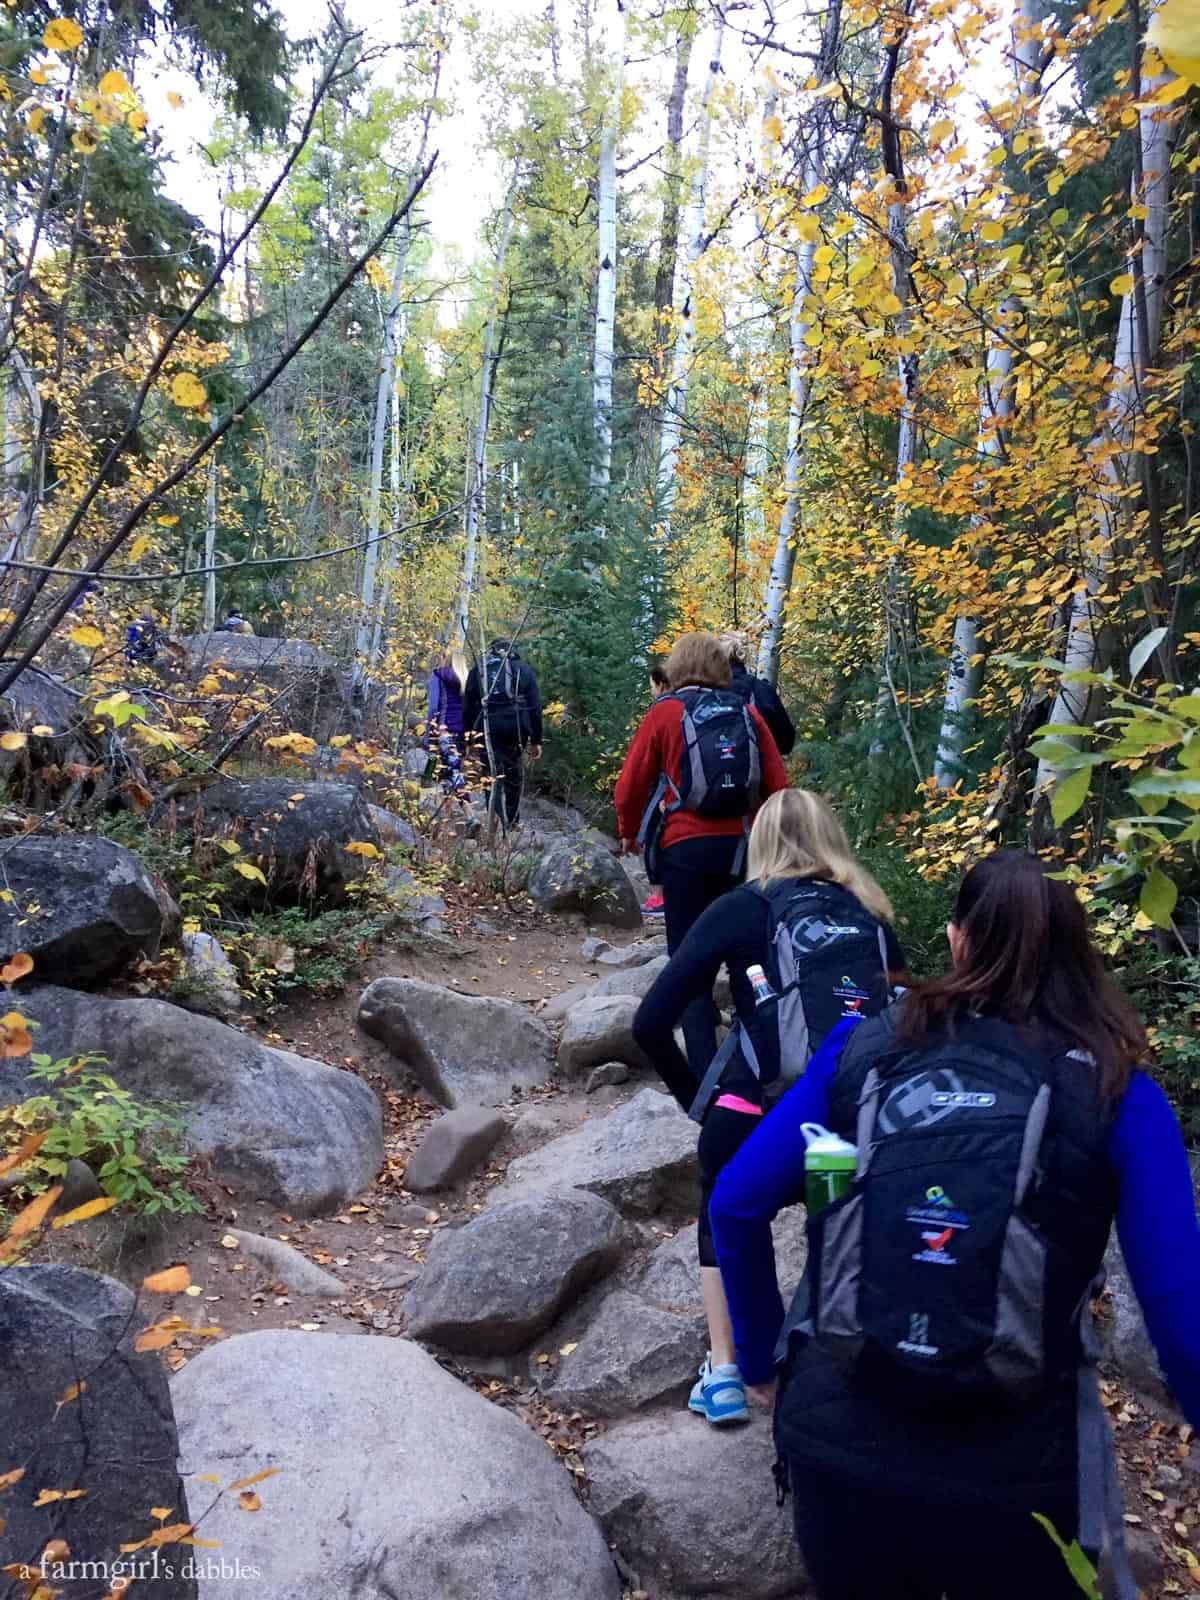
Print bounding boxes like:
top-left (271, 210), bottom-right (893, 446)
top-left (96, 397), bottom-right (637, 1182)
top-left (933, 0), bottom-right (1042, 789)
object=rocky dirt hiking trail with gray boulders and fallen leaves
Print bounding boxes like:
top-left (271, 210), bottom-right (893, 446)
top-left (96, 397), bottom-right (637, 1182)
top-left (9, 812), bottom-right (1200, 1600)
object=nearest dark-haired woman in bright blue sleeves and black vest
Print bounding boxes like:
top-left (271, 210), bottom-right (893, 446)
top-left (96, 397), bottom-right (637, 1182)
top-left (710, 851), bottom-right (1200, 1600)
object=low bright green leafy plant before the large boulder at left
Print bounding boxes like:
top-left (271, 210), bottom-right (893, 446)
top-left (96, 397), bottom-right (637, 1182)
top-left (0, 1054), bottom-right (202, 1216)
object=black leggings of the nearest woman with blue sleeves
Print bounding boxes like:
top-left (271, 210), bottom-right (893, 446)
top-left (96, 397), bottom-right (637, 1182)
top-left (789, 1461), bottom-right (1080, 1600)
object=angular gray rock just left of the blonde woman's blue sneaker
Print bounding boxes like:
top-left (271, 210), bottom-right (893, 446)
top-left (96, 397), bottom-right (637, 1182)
top-left (530, 1290), bottom-right (704, 1416)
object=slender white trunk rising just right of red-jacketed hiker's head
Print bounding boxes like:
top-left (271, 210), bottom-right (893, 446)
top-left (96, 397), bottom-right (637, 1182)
top-left (758, 0), bottom-right (842, 683)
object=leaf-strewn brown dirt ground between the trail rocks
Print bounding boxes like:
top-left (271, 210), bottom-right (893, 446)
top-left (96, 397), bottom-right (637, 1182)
top-left (42, 886), bottom-right (1200, 1600)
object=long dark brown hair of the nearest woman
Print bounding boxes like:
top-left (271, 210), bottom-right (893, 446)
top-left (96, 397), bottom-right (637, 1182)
top-left (896, 850), bottom-right (1149, 1099)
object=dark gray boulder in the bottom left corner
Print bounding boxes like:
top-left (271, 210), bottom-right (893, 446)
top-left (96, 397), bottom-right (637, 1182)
top-left (0, 1266), bottom-right (197, 1600)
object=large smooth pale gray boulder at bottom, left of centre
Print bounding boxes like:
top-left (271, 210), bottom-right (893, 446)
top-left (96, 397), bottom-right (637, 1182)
top-left (170, 1331), bottom-right (621, 1600)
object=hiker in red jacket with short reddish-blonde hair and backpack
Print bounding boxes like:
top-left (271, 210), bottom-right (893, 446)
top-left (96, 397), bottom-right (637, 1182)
top-left (613, 634), bottom-right (787, 1077)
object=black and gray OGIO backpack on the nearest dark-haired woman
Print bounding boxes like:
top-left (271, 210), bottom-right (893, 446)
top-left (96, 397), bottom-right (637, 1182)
top-left (789, 1019), bottom-right (1102, 1402)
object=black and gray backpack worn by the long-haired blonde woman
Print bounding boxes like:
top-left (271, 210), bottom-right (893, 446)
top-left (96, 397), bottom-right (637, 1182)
top-left (690, 878), bottom-right (891, 1122)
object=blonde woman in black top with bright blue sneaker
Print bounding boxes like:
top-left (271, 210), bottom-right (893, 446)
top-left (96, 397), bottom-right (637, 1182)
top-left (634, 789), bottom-right (904, 1427)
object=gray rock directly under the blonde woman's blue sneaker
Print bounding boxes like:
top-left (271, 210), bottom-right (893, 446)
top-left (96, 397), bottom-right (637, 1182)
top-left (581, 1406), bottom-right (805, 1600)
